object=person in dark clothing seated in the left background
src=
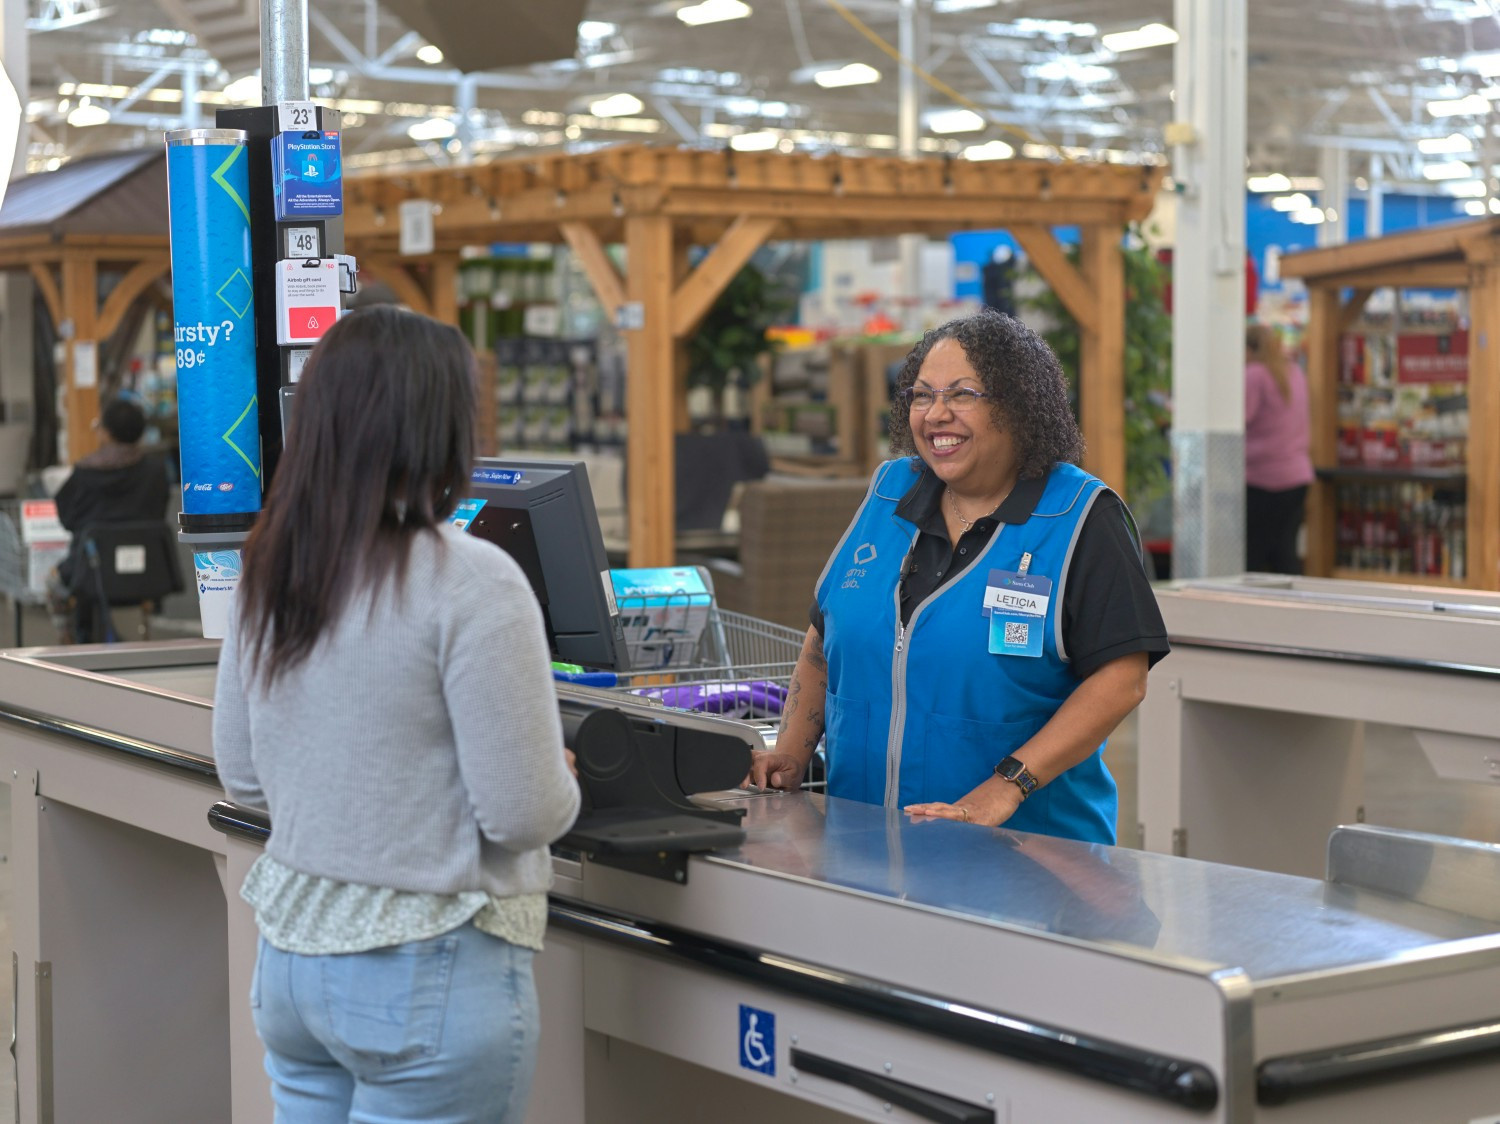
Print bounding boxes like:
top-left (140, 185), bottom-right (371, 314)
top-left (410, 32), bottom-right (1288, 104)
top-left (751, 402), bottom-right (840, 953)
top-left (48, 395), bottom-right (171, 644)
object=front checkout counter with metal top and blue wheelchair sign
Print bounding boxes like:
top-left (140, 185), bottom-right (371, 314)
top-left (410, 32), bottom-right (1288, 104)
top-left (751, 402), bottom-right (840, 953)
top-left (0, 641), bottom-right (1500, 1124)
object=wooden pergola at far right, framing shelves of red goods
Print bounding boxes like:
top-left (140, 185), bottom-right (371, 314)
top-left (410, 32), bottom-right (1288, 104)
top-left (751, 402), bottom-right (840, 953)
top-left (1281, 218), bottom-right (1500, 590)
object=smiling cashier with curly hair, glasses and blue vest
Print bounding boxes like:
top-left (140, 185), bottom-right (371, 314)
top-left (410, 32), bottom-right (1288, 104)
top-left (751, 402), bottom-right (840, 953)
top-left (752, 311), bottom-right (1169, 843)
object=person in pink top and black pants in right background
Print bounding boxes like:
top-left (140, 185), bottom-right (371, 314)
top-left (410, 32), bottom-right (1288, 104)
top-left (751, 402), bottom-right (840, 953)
top-left (1245, 324), bottom-right (1313, 573)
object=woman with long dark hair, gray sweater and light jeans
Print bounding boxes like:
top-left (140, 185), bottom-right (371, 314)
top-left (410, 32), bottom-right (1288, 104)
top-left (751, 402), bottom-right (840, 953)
top-left (213, 308), bottom-right (579, 1124)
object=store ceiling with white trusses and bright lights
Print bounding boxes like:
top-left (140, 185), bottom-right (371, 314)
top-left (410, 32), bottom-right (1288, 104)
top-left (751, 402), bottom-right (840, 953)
top-left (14, 0), bottom-right (1500, 195)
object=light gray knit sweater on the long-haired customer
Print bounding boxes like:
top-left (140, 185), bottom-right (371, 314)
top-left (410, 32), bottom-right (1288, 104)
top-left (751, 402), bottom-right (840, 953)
top-left (213, 527), bottom-right (579, 896)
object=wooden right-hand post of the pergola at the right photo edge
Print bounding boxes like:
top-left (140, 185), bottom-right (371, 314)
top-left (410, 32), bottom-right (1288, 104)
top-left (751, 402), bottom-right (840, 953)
top-left (1464, 261), bottom-right (1500, 590)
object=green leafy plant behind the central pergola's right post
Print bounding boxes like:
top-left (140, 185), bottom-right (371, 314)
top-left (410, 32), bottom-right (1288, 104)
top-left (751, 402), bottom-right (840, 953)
top-left (1026, 229), bottom-right (1172, 512)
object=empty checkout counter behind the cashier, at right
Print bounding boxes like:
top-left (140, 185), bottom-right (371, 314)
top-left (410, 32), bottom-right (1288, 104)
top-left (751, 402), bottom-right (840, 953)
top-left (1139, 575), bottom-right (1500, 876)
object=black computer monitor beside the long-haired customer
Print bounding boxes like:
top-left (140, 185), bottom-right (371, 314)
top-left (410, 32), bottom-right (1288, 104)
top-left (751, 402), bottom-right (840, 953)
top-left (453, 458), bottom-right (630, 671)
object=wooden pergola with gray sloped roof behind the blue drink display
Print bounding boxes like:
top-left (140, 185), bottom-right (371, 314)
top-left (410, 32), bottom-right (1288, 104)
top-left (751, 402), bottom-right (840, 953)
top-left (0, 153), bottom-right (171, 461)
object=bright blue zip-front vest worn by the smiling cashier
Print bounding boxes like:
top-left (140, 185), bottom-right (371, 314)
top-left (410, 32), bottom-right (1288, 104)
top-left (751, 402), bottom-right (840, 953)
top-left (818, 458), bottom-right (1118, 843)
